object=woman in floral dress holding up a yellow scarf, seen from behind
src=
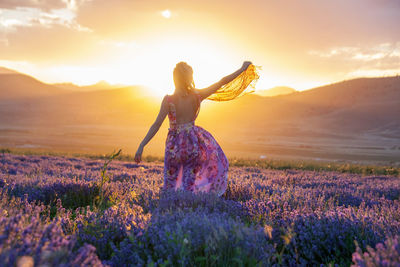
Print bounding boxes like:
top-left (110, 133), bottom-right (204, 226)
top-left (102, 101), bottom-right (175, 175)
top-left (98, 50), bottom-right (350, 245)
top-left (135, 61), bottom-right (258, 196)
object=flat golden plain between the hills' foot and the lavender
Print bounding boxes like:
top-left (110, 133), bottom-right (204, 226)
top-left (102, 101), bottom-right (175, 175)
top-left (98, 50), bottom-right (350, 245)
top-left (0, 125), bottom-right (400, 166)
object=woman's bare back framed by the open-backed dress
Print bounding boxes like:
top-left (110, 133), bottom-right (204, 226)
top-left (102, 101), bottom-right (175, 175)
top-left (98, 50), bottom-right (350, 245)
top-left (169, 92), bottom-right (200, 124)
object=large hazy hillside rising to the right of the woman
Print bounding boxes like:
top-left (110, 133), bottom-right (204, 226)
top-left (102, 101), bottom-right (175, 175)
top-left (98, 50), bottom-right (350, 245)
top-left (203, 76), bottom-right (400, 133)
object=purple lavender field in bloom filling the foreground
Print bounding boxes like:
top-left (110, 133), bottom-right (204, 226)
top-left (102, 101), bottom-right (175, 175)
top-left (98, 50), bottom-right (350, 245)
top-left (0, 153), bottom-right (400, 266)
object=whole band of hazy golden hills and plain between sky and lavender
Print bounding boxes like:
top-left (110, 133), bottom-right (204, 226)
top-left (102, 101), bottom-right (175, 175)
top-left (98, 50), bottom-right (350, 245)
top-left (0, 68), bottom-right (400, 160)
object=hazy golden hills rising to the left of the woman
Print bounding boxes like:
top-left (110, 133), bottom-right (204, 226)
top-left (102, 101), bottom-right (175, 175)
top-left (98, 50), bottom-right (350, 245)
top-left (0, 67), bottom-right (159, 125)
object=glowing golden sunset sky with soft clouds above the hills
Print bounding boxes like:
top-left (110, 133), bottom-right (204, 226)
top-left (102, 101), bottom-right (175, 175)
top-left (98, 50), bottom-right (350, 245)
top-left (0, 0), bottom-right (400, 95)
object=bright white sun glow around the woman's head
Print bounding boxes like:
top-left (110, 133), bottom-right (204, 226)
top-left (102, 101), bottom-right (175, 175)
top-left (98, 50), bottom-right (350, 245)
top-left (101, 35), bottom-right (241, 97)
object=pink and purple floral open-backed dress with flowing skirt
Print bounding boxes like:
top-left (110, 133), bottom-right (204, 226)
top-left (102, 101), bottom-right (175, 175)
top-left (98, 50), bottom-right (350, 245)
top-left (164, 94), bottom-right (229, 196)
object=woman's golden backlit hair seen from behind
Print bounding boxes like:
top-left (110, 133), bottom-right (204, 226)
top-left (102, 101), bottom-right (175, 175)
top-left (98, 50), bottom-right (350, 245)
top-left (174, 61), bottom-right (194, 96)
